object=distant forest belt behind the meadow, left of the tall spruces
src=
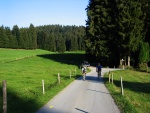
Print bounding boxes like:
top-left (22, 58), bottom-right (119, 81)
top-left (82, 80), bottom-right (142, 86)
top-left (0, 24), bottom-right (85, 52)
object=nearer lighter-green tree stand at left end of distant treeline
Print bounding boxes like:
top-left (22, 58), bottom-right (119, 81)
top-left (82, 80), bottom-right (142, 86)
top-left (0, 24), bottom-right (37, 49)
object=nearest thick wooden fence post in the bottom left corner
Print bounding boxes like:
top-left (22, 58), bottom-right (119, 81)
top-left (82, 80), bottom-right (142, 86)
top-left (2, 80), bottom-right (7, 113)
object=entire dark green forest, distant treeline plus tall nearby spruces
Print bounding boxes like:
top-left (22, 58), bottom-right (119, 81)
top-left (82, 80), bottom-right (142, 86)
top-left (0, 0), bottom-right (150, 67)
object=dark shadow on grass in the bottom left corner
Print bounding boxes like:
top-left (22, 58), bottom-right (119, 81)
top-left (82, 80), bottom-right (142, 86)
top-left (0, 87), bottom-right (41, 113)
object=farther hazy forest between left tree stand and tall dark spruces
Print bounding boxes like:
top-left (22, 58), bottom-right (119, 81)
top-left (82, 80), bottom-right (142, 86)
top-left (36, 25), bottom-right (85, 52)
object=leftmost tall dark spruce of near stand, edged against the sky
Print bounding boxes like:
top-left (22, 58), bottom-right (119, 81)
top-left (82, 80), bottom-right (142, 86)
top-left (85, 0), bottom-right (111, 62)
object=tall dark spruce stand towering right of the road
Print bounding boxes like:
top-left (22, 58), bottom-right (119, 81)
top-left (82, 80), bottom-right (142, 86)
top-left (85, 0), bottom-right (150, 66)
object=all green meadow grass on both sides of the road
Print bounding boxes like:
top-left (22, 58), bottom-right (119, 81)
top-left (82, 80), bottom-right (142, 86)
top-left (0, 49), bottom-right (150, 113)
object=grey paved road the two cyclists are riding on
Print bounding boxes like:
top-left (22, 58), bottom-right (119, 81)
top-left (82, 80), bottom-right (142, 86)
top-left (36, 67), bottom-right (120, 113)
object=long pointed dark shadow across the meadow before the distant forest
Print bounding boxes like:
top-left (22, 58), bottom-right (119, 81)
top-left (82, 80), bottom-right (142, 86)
top-left (37, 53), bottom-right (87, 67)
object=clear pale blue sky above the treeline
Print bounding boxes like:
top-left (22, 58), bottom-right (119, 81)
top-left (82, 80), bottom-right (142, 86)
top-left (0, 0), bottom-right (89, 28)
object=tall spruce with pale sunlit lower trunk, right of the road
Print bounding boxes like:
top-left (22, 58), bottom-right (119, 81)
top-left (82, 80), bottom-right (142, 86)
top-left (117, 0), bottom-right (145, 66)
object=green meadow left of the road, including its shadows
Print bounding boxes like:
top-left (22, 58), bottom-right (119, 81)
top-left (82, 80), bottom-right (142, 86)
top-left (0, 49), bottom-right (86, 113)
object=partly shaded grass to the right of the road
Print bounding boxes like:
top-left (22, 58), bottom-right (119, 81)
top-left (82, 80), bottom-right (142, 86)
top-left (104, 70), bottom-right (150, 113)
